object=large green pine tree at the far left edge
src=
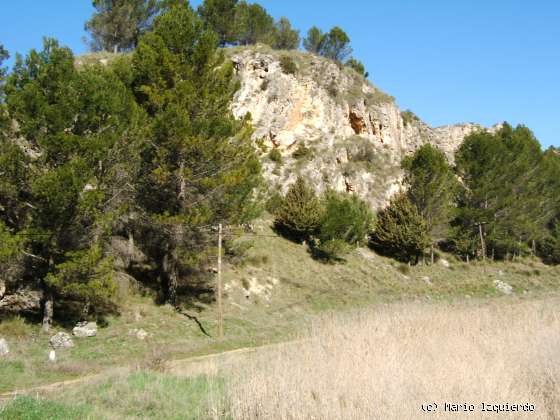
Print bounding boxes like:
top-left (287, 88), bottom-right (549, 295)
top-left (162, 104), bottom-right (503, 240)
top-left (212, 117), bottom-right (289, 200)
top-left (4, 39), bottom-right (135, 326)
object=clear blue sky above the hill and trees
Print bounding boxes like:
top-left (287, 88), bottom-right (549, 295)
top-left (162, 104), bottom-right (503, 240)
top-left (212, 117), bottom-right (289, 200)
top-left (0, 0), bottom-right (560, 147)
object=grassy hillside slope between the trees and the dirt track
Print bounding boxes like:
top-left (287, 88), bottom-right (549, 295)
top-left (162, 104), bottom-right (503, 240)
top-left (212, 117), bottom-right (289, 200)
top-left (0, 213), bottom-right (560, 393)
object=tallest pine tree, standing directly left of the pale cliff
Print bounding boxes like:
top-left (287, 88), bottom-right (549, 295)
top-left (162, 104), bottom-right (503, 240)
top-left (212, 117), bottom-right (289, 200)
top-left (131, 3), bottom-right (260, 303)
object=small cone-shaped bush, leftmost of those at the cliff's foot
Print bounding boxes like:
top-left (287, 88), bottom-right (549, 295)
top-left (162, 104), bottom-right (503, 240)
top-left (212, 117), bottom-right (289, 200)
top-left (274, 177), bottom-right (322, 241)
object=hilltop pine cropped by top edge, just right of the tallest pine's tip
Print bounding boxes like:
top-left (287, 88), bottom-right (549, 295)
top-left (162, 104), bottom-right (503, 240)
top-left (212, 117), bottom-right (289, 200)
top-left (198, 0), bottom-right (238, 47)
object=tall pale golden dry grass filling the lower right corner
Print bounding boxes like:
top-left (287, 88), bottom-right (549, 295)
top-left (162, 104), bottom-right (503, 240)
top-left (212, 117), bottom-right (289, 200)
top-left (227, 298), bottom-right (560, 419)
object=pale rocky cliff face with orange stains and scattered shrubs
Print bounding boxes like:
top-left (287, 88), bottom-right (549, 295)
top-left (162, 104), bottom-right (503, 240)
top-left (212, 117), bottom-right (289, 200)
top-left (228, 46), bottom-right (494, 207)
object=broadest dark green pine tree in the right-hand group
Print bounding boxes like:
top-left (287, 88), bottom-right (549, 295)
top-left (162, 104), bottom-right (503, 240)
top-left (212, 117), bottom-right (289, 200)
top-left (453, 124), bottom-right (554, 258)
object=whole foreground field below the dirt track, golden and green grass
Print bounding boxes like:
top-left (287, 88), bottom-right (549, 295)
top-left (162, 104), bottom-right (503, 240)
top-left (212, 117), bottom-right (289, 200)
top-left (0, 297), bottom-right (560, 420)
